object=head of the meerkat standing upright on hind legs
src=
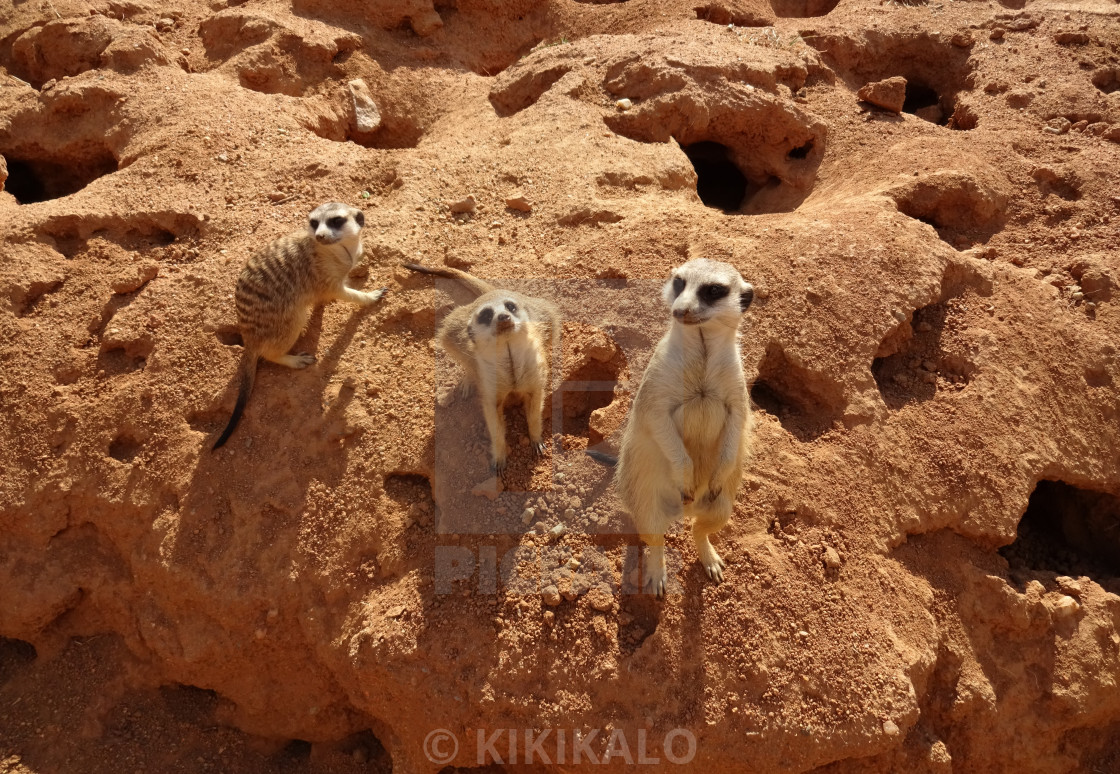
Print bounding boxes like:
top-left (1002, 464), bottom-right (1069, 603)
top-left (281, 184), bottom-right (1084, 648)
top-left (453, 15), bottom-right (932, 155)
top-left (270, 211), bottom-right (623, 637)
top-left (662, 258), bottom-right (755, 328)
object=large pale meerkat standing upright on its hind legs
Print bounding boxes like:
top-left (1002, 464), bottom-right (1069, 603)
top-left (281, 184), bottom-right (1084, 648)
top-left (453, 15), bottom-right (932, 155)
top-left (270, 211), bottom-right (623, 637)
top-left (589, 259), bottom-right (754, 597)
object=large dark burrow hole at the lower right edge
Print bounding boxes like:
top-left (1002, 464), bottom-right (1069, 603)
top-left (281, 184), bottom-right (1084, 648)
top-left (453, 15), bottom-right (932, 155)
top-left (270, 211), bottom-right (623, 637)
top-left (999, 481), bottom-right (1120, 578)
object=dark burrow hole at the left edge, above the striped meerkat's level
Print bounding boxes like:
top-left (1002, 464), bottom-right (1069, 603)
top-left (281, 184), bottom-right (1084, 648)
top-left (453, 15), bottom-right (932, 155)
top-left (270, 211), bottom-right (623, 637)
top-left (3, 146), bottom-right (119, 204)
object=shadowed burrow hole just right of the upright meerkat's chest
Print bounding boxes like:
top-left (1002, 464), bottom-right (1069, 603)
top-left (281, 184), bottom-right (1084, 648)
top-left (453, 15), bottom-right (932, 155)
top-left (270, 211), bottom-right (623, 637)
top-left (750, 344), bottom-right (844, 441)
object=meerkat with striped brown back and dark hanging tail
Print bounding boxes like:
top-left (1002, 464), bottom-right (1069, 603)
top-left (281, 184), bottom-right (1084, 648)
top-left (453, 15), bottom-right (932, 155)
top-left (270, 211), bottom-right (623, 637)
top-left (212, 202), bottom-right (385, 450)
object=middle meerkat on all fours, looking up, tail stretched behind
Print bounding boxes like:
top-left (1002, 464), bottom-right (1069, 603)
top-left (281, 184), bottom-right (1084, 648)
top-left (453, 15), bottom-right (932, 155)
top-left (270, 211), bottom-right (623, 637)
top-left (404, 263), bottom-right (560, 475)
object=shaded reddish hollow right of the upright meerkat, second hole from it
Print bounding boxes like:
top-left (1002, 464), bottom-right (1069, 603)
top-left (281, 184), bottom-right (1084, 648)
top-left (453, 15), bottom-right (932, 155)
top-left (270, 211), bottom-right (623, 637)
top-left (871, 299), bottom-right (977, 410)
